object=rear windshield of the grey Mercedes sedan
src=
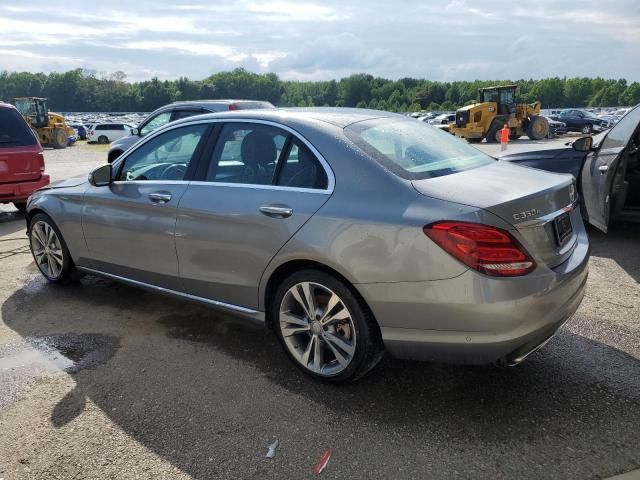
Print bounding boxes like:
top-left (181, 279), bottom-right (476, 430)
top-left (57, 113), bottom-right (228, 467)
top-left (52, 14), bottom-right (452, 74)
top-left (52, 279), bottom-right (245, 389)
top-left (344, 118), bottom-right (495, 180)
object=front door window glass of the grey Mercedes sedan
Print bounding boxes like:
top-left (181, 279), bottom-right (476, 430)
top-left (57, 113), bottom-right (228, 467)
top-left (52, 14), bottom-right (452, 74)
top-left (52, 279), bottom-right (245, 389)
top-left (118, 125), bottom-right (207, 181)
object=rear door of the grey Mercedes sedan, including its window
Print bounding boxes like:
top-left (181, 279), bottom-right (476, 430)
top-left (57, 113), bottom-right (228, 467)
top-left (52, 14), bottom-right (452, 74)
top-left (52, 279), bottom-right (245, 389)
top-left (176, 121), bottom-right (333, 309)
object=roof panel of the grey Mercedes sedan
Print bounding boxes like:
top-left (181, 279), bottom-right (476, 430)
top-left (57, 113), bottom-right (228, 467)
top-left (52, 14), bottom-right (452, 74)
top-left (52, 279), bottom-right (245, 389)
top-left (172, 107), bottom-right (400, 128)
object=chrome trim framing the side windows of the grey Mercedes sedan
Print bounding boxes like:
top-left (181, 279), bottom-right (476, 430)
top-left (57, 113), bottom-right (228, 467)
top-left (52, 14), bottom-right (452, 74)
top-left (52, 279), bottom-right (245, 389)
top-left (112, 116), bottom-right (336, 195)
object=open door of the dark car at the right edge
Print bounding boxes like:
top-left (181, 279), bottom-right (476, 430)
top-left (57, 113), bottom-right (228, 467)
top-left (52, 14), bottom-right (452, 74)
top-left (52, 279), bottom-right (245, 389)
top-left (581, 107), bottom-right (640, 233)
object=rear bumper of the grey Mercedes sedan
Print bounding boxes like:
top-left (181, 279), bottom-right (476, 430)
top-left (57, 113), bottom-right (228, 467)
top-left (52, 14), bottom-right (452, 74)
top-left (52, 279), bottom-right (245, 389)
top-left (357, 231), bottom-right (589, 364)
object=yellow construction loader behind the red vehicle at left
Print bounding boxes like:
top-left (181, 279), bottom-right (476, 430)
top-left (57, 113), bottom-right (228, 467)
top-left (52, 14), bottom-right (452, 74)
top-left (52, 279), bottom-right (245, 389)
top-left (13, 97), bottom-right (75, 148)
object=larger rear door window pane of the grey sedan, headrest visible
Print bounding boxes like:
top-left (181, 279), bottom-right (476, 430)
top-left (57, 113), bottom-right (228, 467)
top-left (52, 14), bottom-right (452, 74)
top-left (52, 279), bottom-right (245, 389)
top-left (206, 123), bottom-right (288, 185)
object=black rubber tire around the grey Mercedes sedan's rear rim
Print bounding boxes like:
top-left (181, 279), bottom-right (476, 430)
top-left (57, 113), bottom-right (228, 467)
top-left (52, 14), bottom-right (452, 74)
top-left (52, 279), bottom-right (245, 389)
top-left (270, 270), bottom-right (384, 382)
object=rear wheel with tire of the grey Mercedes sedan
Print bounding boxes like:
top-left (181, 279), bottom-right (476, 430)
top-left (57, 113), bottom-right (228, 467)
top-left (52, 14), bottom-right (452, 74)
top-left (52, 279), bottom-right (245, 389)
top-left (271, 270), bottom-right (384, 382)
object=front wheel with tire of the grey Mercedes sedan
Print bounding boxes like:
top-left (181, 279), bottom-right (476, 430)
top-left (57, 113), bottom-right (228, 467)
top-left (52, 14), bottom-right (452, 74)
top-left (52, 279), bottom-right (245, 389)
top-left (28, 213), bottom-right (82, 283)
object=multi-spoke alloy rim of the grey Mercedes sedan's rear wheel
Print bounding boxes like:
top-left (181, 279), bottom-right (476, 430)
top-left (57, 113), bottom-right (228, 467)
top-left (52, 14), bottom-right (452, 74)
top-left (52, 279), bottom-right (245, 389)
top-left (279, 282), bottom-right (356, 377)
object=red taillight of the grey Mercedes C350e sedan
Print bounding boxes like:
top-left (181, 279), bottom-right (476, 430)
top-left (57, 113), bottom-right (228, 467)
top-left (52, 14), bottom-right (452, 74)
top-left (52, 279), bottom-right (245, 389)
top-left (423, 221), bottom-right (536, 277)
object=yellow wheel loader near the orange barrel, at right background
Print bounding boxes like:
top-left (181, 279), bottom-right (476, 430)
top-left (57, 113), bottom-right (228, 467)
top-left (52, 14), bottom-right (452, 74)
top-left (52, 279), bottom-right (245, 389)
top-left (449, 85), bottom-right (549, 143)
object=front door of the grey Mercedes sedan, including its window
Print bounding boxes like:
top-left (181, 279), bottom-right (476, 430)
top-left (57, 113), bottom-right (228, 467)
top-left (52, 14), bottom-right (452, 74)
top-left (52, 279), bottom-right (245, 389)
top-left (82, 123), bottom-right (209, 290)
